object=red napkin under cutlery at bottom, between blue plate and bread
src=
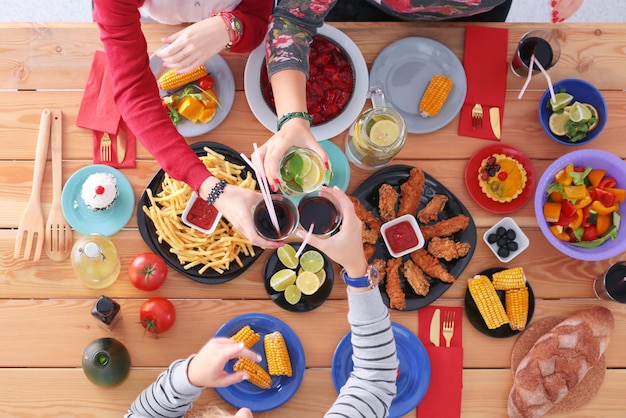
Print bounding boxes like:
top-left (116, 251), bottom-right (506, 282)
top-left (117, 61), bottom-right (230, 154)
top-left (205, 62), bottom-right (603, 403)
top-left (417, 306), bottom-right (463, 418)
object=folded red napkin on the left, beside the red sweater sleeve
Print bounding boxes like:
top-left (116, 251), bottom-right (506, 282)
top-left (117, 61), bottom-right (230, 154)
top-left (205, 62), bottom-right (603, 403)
top-left (76, 51), bottom-right (137, 168)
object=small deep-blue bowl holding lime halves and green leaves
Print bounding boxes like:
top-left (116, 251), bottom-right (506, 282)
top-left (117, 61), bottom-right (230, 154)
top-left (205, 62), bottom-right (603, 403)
top-left (539, 78), bottom-right (607, 146)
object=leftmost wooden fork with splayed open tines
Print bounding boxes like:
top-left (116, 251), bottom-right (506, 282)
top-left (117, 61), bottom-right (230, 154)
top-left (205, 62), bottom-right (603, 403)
top-left (13, 109), bottom-right (50, 261)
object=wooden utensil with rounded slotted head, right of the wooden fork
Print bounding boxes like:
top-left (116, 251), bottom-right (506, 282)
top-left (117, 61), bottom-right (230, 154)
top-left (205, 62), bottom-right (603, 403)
top-left (44, 110), bottom-right (72, 261)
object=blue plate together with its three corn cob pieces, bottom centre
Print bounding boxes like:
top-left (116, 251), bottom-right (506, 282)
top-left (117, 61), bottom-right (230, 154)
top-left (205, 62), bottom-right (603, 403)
top-left (215, 313), bottom-right (306, 412)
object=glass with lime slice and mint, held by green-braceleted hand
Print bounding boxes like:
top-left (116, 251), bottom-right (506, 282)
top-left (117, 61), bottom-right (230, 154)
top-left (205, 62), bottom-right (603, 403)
top-left (280, 147), bottom-right (332, 196)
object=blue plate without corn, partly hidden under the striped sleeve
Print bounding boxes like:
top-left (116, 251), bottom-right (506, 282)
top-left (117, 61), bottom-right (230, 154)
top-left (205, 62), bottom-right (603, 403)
top-left (332, 322), bottom-right (430, 418)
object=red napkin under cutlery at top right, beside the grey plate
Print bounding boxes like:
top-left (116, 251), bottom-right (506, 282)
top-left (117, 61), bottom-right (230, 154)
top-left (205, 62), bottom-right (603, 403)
top-left (459, 26), bottom-right (509, 141)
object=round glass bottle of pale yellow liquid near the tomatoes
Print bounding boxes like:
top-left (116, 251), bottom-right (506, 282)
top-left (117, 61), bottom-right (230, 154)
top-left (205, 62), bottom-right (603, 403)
top-left (71, 234), bottom-right (120, 289)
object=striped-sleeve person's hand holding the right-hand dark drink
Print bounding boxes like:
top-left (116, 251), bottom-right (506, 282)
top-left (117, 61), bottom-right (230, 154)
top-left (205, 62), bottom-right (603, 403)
top-left (297, 187), bottom-right (367, 277)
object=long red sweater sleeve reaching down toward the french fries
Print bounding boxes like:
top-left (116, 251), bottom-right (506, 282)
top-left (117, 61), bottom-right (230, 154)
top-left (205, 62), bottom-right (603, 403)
top-left (94, 0), bottom-right (210, 191)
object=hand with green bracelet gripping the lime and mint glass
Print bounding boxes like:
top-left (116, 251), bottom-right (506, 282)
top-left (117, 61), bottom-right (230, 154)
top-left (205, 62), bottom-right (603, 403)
top-left (256, 118), bottom-right (329, 192)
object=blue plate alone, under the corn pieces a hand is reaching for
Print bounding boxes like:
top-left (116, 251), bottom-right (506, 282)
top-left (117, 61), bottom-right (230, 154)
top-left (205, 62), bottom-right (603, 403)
top-left (215, 313), bottom-right (305, 412)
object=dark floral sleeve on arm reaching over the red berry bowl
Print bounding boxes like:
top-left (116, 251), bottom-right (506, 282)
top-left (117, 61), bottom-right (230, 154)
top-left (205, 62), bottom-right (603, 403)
top-left (265, 0), bottom-right (336, 77)
